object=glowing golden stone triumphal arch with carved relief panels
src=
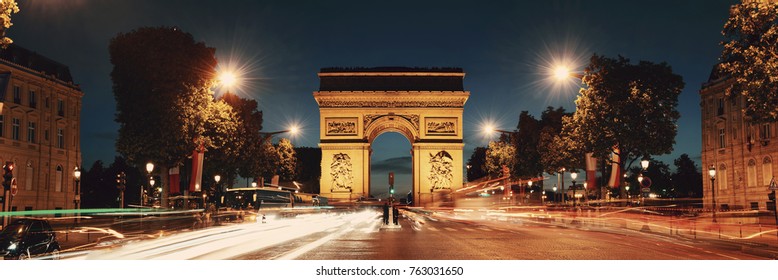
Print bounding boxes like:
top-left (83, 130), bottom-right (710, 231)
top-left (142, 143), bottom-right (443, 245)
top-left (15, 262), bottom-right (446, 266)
top-left (313, 67), bottom-right (470, 205)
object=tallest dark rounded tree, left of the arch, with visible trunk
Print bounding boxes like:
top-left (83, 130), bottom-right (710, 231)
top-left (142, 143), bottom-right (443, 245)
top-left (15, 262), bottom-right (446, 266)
top-left (109, 27), bottom-right (217, 207)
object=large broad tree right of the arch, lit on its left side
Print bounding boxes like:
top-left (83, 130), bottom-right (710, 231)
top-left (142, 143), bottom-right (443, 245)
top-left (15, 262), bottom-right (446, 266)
top-left (552, 55), bottom-right (684, 178)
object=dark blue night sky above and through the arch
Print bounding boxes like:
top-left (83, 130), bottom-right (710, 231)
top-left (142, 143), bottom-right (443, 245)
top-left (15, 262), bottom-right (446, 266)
top-left (7, 0), bottom-right (739, 193)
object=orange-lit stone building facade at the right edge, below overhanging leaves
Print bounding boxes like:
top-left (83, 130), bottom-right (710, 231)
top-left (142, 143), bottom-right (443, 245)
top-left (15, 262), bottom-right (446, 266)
top-left (700, 70), bottom-right (778, 210)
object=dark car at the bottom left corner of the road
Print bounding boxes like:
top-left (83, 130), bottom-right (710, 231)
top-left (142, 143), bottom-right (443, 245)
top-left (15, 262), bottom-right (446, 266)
top-left (0, 219), bottom-right (59, 260)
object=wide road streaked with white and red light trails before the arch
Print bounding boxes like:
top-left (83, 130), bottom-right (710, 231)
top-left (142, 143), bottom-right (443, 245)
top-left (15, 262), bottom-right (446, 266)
top-left (57, 209), bottom-right (768, 260)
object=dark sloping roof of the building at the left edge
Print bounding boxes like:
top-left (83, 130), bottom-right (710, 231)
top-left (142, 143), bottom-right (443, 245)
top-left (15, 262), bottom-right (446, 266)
top-left (0, 44), bottom-right (73, 83)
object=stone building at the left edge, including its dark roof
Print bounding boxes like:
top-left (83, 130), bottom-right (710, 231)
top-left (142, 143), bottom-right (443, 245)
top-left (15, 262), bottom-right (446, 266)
top-left (0, 44), bottom-right (84, 211)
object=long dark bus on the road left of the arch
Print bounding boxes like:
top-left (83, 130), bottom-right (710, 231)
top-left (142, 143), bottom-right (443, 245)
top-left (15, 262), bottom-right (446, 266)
top-left (221, 187), bottom-right (294, 210)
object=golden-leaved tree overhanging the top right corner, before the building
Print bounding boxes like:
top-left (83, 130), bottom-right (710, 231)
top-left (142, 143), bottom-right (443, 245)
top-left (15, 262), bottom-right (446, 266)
top-left (718, 1), bottom-right (778, 123)
